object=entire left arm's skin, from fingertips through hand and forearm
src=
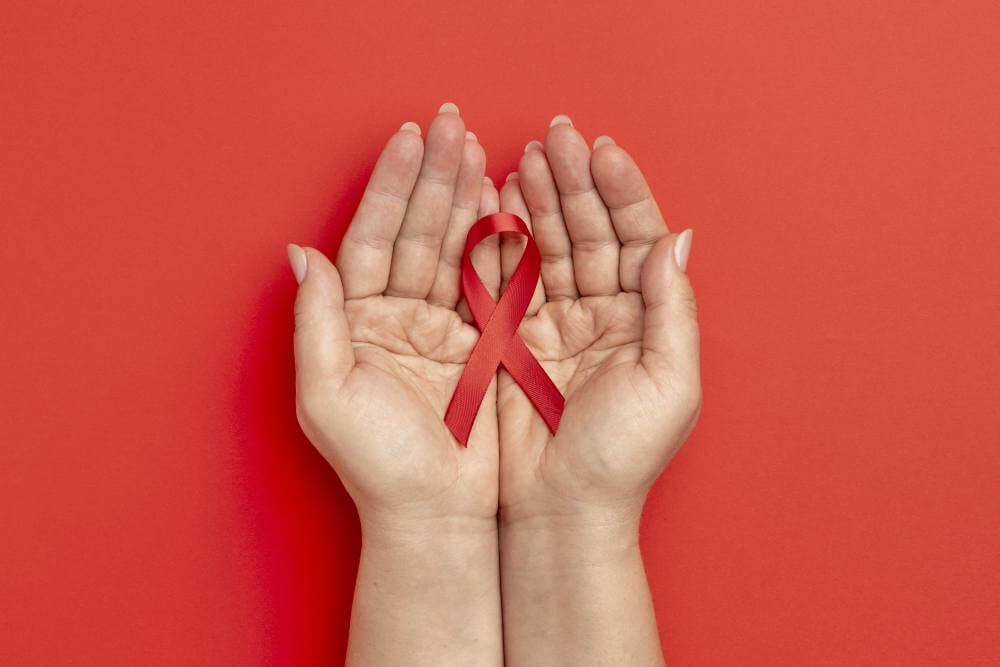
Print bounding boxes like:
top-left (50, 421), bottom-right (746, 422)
top-left (290, 102), bottom-right (503, 665)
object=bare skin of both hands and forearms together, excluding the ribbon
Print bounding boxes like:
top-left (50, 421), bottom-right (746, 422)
top-left (289, 104), bottom-right (700, 665)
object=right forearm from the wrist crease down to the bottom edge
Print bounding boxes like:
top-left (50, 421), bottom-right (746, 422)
top-left (500, 508), bottom-right (663, 665)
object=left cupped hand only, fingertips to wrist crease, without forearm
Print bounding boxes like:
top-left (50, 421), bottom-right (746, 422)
top-left (289, 104), bottom-right (500, 526)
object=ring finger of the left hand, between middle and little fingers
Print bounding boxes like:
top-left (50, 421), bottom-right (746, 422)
top-left (427, 132), bottom-right (486, 309)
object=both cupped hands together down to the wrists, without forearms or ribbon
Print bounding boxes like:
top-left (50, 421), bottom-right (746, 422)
top-left (289, 104), bottom-right (700, 535)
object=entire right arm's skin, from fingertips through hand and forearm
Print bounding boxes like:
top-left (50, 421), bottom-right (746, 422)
top-left (498, 117), bottom-right (701, 665)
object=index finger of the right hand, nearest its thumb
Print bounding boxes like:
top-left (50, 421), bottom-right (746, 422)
top-left (590, 136), bottom-right (667, 292)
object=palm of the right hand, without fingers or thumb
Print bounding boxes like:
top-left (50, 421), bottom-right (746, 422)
top-left (498, 292), bottom-right (688, 506)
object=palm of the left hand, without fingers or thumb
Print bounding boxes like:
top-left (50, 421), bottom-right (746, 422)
top-left (330, 296), bottom-right (497, 514)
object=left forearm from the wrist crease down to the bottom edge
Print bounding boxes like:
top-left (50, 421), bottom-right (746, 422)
top-left (347, 520), bottom-right (503, 666)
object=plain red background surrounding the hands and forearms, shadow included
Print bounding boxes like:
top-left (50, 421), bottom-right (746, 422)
top-left (0, 0), bottom-right (1000, 665)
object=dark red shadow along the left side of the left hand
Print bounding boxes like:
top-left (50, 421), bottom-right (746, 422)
top-left (233, 159), bottom-right (376, 664)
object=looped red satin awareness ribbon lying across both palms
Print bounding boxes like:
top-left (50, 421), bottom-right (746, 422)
top-left (444, 213), bottom-right (566, 445)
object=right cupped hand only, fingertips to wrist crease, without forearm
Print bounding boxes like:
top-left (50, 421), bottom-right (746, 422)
top-left (498, 116), bottom-right (701, 523)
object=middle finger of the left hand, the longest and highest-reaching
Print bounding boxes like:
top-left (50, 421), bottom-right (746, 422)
top-left (385, 103), bottom-right (465, 299)
